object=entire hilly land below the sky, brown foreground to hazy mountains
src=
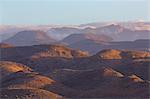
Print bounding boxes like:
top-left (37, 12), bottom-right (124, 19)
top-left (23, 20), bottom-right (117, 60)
top-left (0, 23), bottom-right (150, 99)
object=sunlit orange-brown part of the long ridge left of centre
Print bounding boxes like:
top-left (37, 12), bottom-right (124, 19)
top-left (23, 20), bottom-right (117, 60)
top-left (31, 45), bottom-right (88, 58)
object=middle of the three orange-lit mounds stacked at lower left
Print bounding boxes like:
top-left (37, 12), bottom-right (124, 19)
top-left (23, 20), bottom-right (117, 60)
top-left (1, 71), bottom-right (55, 88)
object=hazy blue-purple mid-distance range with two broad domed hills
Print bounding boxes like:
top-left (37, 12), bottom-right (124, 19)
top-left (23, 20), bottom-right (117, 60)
top-left (2, 30), bottom-right (150, 54)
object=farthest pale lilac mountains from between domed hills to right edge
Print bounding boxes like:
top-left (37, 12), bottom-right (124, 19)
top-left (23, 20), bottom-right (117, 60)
top-left (48, 24), bottom-right (150, 41)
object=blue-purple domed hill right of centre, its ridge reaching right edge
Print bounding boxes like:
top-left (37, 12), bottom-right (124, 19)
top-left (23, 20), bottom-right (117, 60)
top-left (68, 39), bottom-right (150, 54)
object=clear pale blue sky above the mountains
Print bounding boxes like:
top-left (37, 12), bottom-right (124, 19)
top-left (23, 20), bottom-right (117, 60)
top-left (0, 0), bottom-right (150, 25)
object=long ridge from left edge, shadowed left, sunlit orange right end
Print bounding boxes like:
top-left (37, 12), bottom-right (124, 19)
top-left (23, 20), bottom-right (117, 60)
top-left (1, 45), bottom-right (89, 61)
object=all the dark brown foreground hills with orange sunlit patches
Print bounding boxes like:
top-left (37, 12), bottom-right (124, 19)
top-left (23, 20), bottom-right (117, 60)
top-left (0, 45), bottom-right (150, 99)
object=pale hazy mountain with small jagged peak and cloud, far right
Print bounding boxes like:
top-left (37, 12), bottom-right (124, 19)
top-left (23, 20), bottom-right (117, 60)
top-left (81, 22), bottom-right (150, 41)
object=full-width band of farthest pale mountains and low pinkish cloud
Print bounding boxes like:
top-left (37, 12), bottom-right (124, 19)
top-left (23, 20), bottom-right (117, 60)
top-left (0, 22), bottom-right (150, 41)
